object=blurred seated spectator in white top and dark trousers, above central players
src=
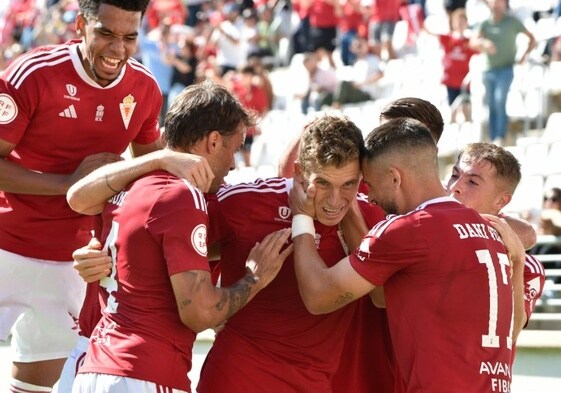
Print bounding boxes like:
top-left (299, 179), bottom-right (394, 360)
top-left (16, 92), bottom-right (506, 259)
top-left (332, 37), bottom-right (384, 108)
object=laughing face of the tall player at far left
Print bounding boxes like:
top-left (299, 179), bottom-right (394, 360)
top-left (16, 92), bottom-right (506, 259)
top-left (76, 4), bottom-right (141, 86)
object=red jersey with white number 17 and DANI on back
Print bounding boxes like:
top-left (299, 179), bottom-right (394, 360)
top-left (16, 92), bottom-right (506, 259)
top-left (350, 197), bottom-right (513, 393)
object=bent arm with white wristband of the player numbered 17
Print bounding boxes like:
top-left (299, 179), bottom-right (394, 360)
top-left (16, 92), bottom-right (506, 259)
top-left (290, 179), bottom-right (374, 314)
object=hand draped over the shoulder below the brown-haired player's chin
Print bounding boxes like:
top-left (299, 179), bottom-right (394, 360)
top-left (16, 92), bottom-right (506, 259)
top-left (160, 149), bottom-right (214, 192)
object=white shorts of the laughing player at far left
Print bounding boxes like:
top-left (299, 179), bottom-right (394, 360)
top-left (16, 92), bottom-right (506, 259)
top-left (0, 250), bottom-right (86, 363)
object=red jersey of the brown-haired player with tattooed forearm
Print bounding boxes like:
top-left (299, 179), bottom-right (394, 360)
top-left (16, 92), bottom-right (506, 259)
top-left (80, 171), bottom-right (209, 391)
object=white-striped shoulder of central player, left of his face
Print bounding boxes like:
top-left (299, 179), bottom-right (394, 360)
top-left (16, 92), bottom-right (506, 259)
top-left (216, 177), bottom-right (292, 202)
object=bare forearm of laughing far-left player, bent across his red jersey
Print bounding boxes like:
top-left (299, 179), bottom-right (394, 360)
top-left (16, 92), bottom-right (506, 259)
top-left (0, 139), bottom-right (121, 195)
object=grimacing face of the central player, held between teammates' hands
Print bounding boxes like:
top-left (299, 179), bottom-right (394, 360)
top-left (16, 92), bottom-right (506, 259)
top-left (305, 160), bottom-right (360, 226)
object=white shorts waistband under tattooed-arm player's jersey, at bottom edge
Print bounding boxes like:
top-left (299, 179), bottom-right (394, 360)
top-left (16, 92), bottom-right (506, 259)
top-left (72, 373), bottom-right (187, 393)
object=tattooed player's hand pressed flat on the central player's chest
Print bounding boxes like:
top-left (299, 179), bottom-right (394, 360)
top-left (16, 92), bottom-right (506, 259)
top-left (245, 228), bottom-right (294, 288)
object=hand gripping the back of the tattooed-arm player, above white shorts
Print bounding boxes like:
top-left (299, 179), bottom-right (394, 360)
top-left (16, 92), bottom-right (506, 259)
top-left (72, 237), bottom-right (113, 282)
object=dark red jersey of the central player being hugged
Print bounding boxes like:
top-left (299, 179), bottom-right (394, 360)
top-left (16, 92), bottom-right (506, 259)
top-left (198, 178), bottom-right (384, 393)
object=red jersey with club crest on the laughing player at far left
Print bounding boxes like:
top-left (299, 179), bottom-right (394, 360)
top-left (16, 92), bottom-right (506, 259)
top-left (0, 41), bottom-right (162, 261)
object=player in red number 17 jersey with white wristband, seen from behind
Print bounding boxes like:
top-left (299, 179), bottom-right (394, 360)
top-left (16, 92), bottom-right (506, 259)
top-left (291, 119), bottom-right (524, 392)
